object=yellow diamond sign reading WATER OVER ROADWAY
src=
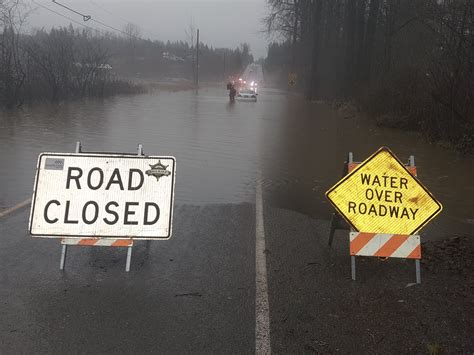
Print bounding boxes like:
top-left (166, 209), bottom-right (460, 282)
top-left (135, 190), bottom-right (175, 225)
top-left (326, 147), bottom-right (442, 235)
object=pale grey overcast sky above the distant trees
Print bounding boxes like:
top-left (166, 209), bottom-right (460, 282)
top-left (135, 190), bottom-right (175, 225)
top-left (28, 0), bottom-right (268, 59)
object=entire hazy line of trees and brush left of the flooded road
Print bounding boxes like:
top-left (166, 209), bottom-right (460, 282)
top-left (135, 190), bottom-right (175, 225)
top-left (0, 0), bottom-right (253, 108)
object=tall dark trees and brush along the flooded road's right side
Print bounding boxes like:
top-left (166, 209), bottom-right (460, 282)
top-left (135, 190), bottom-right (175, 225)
top-left (264, 0), bottom-right (474, 151)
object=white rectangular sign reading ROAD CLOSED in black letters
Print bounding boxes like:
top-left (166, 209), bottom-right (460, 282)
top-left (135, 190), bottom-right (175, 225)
top-left (29, 153), bottom-right (176, 239)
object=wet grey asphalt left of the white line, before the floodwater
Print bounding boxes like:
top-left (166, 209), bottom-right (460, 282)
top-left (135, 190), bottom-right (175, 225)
top-left (0, 204), bottom-right (255, 354)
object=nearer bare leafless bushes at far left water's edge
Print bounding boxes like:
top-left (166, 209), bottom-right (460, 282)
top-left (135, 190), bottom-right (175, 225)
top-left (0, 0), bottom-right (142, 108)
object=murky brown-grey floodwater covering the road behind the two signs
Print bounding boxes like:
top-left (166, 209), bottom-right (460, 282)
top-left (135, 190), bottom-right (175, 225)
top-left (0, 87), bottom-right (474, 239)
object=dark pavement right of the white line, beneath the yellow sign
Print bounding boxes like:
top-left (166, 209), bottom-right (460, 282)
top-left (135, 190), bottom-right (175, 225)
top-left (265, 208), bottom-right (474, 354)
